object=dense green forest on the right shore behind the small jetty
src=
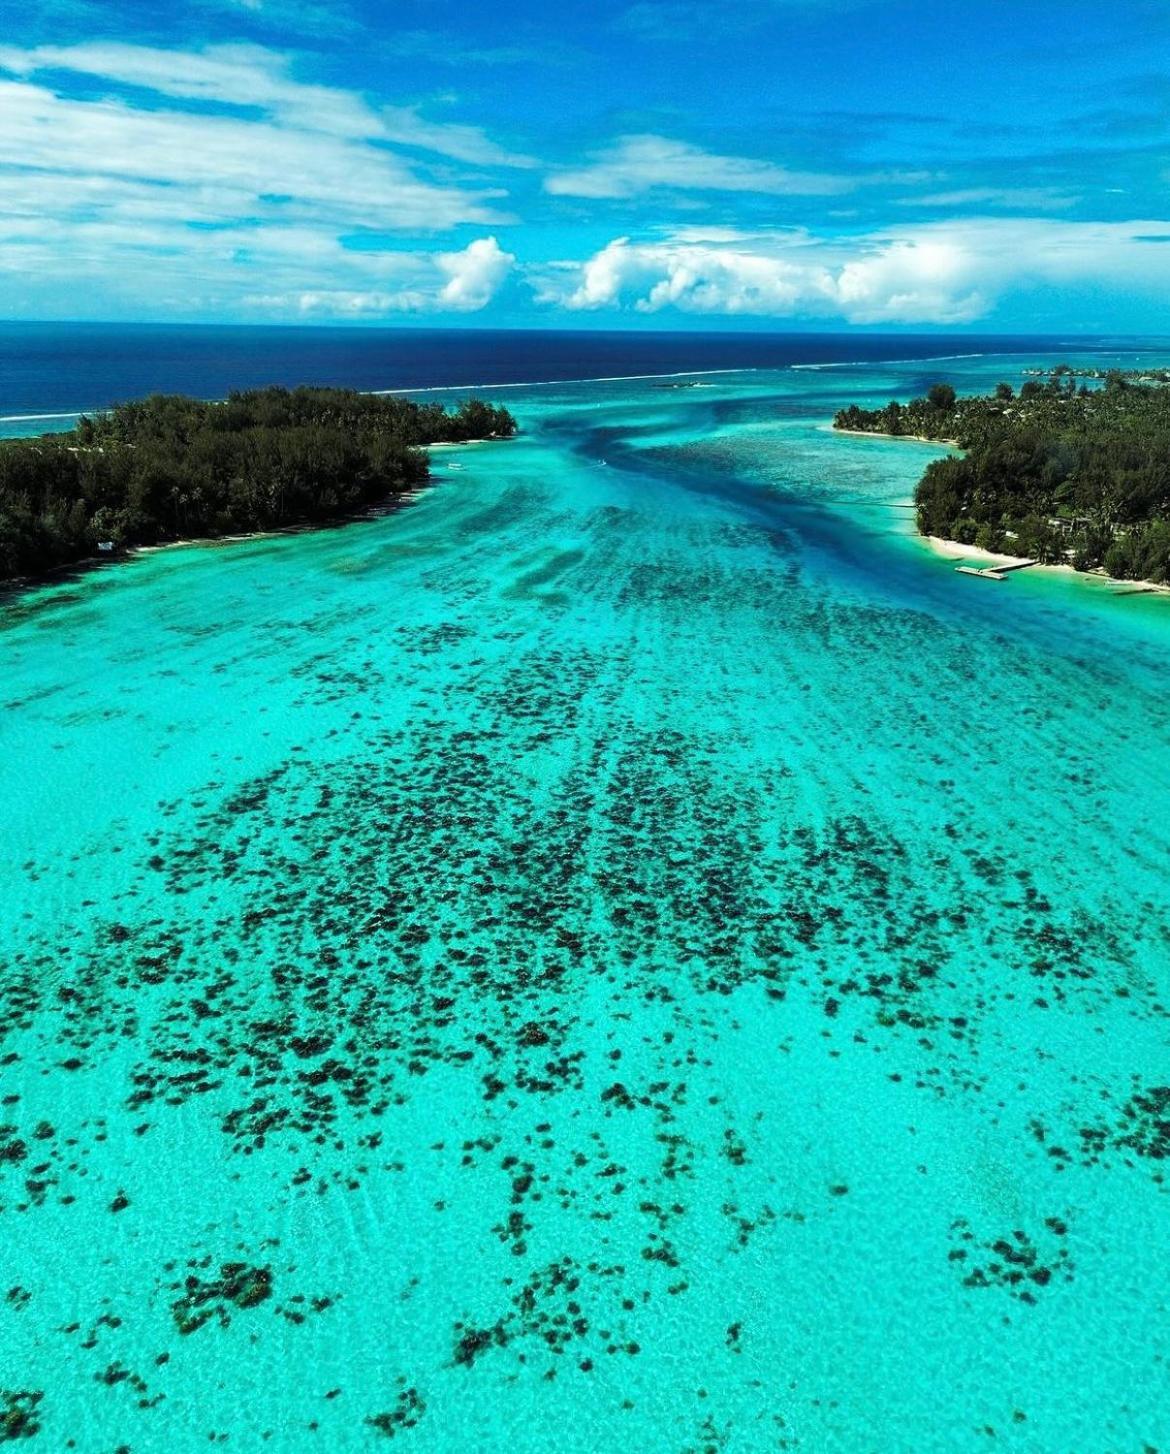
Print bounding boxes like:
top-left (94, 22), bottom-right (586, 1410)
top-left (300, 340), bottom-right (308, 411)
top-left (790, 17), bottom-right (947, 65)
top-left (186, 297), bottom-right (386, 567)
top-left (834, 365), bottom-right (1170, 582)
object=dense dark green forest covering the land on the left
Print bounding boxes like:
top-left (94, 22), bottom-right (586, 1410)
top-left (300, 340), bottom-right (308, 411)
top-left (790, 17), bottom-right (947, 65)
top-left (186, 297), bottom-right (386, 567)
top-left (0, 388), bottom-right (516, 580)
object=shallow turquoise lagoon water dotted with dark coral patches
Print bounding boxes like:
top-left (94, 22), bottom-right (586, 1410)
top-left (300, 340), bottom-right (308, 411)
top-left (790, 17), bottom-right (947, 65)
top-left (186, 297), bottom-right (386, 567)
top-left (0, 359), bottom-right (1170, 1454)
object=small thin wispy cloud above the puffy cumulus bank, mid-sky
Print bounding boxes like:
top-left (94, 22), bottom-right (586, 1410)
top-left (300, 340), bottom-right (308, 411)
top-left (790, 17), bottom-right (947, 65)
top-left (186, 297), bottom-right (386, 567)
top-left (545, 135), bottom-right (853, 198)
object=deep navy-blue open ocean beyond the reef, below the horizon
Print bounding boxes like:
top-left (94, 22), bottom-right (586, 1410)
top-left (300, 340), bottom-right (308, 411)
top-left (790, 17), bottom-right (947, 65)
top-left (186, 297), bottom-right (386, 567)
top-left (0, 323), bottom-right (1148, 433)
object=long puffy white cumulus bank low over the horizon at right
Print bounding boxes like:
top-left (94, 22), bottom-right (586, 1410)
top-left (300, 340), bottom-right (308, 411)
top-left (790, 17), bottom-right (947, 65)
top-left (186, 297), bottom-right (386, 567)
top-left (536, 218), bottom-right (1170, 324)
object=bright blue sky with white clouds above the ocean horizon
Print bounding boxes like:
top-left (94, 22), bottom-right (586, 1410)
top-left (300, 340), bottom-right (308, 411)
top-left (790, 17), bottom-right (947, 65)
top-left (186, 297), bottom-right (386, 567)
top-left (0, 0), bottom-right (1170, 333)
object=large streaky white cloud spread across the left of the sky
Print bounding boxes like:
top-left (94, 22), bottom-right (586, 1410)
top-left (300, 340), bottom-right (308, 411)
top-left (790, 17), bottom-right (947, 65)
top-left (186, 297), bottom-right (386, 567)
top-left (0, 42), bottom-right (526, 316)
